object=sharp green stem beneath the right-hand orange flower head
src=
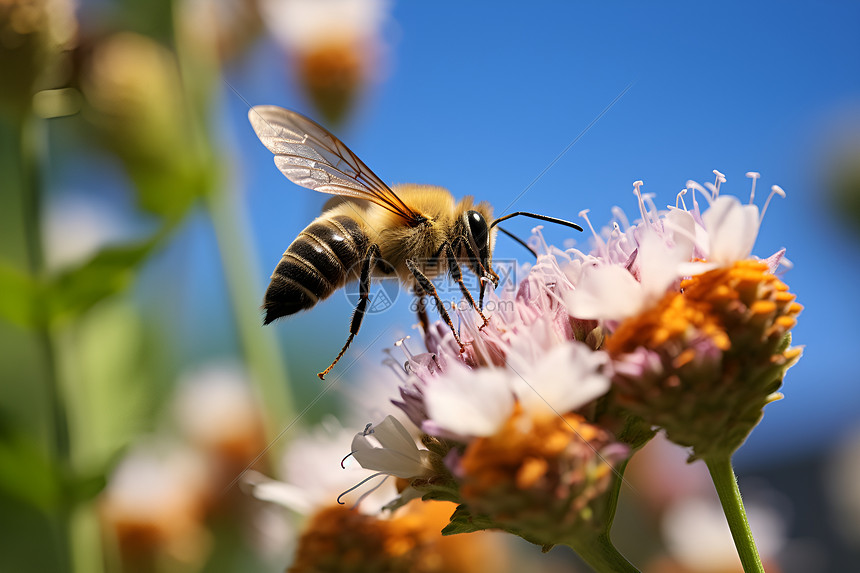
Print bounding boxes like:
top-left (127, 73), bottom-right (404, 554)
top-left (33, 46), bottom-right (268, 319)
top-left (705, 457), bottom-right (764, 573)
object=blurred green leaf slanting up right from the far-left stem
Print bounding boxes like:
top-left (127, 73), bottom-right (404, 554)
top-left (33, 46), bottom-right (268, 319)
top-left (44, 233), bottom-right (161, 320)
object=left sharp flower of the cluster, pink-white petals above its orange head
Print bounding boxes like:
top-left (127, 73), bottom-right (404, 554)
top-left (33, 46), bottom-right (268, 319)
top-left (353, 242), bottom-right (629, 546)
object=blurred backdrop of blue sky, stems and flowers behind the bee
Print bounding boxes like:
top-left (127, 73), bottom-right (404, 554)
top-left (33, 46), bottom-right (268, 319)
top-left (0, 0), bottom-right (860, 572)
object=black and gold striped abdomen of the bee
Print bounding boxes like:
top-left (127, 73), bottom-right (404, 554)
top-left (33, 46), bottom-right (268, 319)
top-left (263, 215), bottom-right (368, 324)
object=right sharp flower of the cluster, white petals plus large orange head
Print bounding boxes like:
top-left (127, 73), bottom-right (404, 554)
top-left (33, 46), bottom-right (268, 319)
top-left (568, 173), bottom-right (802, 458)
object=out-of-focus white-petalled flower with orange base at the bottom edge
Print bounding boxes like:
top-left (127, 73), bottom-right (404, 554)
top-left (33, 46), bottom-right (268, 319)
top-left (246, 417), bottom-right (505, 573)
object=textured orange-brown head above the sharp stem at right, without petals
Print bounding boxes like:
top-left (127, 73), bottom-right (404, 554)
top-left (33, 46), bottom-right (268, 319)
top-left (606, 259), bottom-right (803, 457)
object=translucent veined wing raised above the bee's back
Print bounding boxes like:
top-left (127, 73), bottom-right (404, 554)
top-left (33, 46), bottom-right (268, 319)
top-left (248, 105), bottom-right (422, 225)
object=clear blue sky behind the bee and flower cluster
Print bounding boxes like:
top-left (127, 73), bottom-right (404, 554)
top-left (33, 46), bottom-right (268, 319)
top-left (201, 2), bottom-right (860, 465)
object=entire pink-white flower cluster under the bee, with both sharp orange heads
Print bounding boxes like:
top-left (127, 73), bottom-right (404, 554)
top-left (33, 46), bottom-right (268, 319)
top-left (354, 172), bottom-right (801, 557)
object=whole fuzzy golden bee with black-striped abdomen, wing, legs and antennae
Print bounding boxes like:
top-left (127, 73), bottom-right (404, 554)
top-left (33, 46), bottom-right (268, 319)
top-left (248, 105), bottom-right (582, 379)
